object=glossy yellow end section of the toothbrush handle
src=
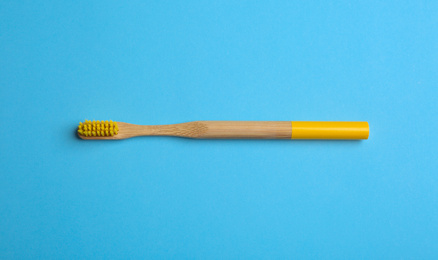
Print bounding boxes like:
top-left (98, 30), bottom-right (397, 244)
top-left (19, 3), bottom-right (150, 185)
top-left (292, 121), bottom-right (370, 140)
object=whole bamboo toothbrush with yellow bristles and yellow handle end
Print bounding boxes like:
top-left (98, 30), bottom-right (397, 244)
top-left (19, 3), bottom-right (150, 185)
top-left (78, 120), bottom-right (369, 140)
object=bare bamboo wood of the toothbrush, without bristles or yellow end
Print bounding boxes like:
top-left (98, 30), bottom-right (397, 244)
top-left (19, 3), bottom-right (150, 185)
top-left (79, 121), bottom-right (292, 140)
